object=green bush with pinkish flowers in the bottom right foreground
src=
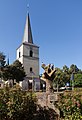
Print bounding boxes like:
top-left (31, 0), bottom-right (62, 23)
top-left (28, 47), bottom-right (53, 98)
top-left (57, 91), bottom-right (82, 120)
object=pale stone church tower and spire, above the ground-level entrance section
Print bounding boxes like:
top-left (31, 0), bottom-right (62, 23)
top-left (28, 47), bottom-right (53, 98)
top-left (17, 13), bottom-right (39, 79)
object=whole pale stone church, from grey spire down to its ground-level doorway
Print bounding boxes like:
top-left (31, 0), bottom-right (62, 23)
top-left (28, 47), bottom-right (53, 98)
top-left (17, 13), bottom-right (40, 91)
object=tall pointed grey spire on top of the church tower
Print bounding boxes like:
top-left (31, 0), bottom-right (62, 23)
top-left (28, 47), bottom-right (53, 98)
top-left (22, 13), bottom-right (33, 44)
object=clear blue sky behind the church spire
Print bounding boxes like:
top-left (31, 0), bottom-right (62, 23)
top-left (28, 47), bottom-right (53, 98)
top-left (0, 0), bottom-right (82, 72)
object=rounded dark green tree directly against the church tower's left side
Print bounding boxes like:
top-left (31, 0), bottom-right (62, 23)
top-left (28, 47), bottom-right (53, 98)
top-left (3, 60), bottom-right (26, 82)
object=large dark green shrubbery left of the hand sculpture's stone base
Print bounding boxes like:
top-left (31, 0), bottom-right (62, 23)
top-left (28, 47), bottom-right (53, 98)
top-left (0, 86), bottom-right (56, 120)
